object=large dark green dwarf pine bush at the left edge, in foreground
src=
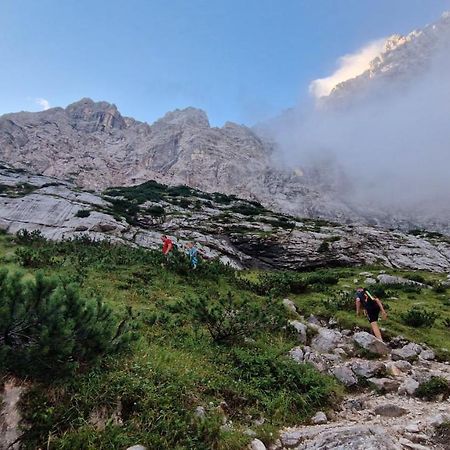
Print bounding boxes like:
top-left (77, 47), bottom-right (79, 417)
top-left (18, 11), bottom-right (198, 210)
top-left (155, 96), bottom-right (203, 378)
top-left (0, 269), bottom-right (135, 378)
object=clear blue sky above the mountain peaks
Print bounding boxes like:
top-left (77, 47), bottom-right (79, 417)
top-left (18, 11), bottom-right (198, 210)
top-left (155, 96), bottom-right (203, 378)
top-left (0, 0), bottom-right (450, 125)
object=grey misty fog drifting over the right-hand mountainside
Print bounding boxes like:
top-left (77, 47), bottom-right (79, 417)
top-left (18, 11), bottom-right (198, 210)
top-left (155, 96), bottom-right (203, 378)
top-left (271, 27), bottom-right (450, 217)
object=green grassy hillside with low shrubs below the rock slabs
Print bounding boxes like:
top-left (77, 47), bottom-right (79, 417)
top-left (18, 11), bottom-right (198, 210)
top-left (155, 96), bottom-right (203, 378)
top-left (0, 230), bottom-right (450, 450)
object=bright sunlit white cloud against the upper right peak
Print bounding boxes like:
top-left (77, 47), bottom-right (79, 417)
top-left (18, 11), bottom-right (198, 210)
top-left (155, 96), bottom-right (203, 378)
top-left (309, 39), bottom-right (386, 98)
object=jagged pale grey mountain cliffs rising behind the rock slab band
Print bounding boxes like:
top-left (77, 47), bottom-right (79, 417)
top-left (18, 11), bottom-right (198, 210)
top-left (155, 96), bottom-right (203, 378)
top-left (0, 99), bottom-right (450, 232)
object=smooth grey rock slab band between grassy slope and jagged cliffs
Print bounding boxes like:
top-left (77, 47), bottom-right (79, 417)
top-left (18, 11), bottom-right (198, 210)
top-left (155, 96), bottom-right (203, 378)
top-left (0, 166), bottom-right (450, 271)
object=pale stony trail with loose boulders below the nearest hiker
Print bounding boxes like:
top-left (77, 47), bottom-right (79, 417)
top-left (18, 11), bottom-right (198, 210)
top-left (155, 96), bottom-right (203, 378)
top-left (251, 308), bottom-right (450, 450)
